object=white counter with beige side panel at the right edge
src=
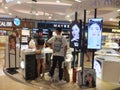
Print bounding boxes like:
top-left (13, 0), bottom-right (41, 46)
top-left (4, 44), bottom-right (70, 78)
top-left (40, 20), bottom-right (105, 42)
top-left (94, 49), bottom-right (120, 83)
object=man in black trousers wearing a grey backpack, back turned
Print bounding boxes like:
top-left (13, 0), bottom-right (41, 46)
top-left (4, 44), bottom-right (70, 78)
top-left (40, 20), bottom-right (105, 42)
top-left (46, 27), bottom-right (67, 83)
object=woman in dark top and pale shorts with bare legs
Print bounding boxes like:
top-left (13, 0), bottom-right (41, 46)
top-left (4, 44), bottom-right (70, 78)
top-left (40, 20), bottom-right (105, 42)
top-left (35, 35), bottom-right (45, 81)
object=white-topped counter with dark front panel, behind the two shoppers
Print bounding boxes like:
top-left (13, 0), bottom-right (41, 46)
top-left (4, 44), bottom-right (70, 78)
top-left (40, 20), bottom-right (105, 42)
top-left (21, 48), bottom-right (72, 80)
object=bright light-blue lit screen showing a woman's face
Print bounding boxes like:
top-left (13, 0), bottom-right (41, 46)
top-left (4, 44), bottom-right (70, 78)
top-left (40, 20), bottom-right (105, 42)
top-left (87, 18), bottom-right (103, 49)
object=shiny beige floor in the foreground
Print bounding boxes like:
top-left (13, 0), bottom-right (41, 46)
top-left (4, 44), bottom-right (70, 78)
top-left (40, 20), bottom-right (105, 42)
top-left (0, 47), bottom-right (120, 90)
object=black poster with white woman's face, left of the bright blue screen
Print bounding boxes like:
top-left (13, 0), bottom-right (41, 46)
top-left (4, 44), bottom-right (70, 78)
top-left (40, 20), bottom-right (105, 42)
top-left (70, 21), bottom-right (81, 48)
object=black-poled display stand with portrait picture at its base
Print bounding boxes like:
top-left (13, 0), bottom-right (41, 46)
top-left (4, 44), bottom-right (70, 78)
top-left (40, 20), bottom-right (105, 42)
top-left (78, 9), bottom-right (96, 88)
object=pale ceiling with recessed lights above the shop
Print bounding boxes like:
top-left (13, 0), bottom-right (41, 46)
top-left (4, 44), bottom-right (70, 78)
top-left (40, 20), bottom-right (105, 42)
top-left (0, 0), bottom-right (120, 21)
